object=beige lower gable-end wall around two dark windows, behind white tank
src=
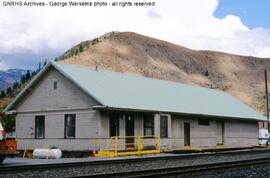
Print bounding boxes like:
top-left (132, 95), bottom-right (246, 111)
top-left (16, 110), bottom-right (103, 150)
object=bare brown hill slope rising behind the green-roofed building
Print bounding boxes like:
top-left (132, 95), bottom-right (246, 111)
top-left (58, 32), bottom-right (270, 113)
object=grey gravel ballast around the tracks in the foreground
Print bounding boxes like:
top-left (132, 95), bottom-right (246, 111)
top-left (0, 148), bottom-right (270, 177)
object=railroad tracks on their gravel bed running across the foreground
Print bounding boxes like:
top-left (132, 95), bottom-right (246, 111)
top-left (0, 149), bottom-right (270, 177)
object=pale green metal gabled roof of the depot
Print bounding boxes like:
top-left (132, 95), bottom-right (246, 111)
top-left (6, 62), bottom-right (266, 121)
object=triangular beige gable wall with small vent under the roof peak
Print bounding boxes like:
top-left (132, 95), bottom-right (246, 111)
top-left (16, 69), bottom-right (98, 112)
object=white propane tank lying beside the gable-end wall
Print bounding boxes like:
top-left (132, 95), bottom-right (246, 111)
top-left (33, 148), bottom-right (62, 159)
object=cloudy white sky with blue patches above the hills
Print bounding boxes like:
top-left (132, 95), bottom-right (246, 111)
top-left (0, 0), bottom-right (270, 70)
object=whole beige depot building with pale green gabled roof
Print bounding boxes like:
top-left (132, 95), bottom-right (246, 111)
top-left (5, 62), bottom-right (266, 151)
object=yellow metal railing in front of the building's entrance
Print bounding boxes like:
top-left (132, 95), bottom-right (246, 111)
top-left (94, 135), bottom-right (160, 157)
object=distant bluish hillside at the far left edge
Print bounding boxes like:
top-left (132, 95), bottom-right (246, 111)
top-left (0, 69), bottom-right (26, 91)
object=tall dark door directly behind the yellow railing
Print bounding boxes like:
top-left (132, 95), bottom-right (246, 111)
top-left (125, 115), bottom-right (134, 148)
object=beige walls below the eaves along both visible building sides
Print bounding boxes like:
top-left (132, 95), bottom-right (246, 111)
top-left (16, 110), bottom-right (258, 150)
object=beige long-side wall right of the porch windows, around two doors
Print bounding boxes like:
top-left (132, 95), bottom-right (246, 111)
top-left (171, 116), bottom-right (258, 149)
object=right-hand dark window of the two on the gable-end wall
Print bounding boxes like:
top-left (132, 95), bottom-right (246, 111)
top-left (65, 114), bottom-right (76, 138)
